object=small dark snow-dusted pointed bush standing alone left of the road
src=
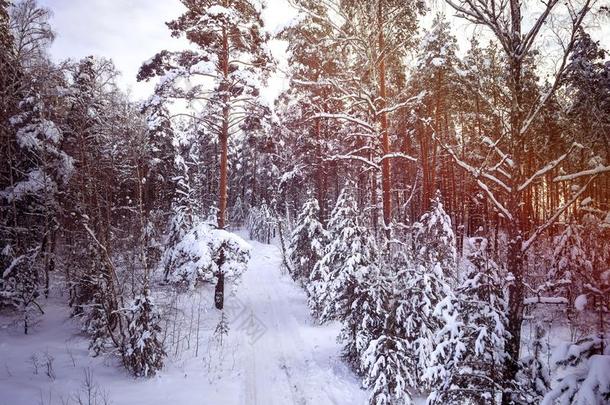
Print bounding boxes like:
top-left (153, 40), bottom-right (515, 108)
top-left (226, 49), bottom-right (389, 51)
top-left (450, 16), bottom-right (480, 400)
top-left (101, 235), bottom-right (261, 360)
top-left (122, 287), bottom-right (166, 377)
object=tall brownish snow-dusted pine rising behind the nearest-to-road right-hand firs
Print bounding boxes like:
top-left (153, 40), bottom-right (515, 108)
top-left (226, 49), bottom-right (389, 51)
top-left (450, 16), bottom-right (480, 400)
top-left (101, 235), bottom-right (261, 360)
top-left (275, 0), bottom-right (342, 210)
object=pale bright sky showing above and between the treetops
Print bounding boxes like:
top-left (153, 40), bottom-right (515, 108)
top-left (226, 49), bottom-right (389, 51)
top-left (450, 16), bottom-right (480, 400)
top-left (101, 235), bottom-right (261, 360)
top-left (39, 0), bottom-right (610, 101)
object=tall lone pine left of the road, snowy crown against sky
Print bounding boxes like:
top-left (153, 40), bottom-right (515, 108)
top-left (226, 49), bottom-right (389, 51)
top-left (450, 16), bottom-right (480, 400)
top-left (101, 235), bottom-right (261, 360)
top-left (138, 0), bottom-right (272, 309)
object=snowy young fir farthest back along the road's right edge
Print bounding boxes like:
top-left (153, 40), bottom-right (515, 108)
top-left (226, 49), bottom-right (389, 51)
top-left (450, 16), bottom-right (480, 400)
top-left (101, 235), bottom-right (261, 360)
top-left (288, 198), bottom-right (328, 283)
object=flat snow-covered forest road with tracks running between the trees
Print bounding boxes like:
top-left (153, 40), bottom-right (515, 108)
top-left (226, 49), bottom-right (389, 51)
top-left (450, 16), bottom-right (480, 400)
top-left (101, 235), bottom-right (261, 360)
top-left (237, 238), bottom-right (366, 405)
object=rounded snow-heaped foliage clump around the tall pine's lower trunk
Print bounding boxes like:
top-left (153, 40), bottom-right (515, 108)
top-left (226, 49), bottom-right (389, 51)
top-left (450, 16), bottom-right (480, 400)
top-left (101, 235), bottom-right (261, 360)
top-left (164, 222), bottom-right (250, 288)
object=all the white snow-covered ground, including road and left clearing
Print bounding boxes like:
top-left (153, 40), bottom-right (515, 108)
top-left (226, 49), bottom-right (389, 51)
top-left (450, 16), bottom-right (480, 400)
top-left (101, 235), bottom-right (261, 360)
top-left (0, 235), bottom-right (367, 405)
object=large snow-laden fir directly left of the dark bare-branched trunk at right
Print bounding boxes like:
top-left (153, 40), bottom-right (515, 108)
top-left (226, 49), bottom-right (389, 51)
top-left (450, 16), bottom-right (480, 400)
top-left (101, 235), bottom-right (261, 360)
top-left (427, 237), bottom-right (512, 404)
